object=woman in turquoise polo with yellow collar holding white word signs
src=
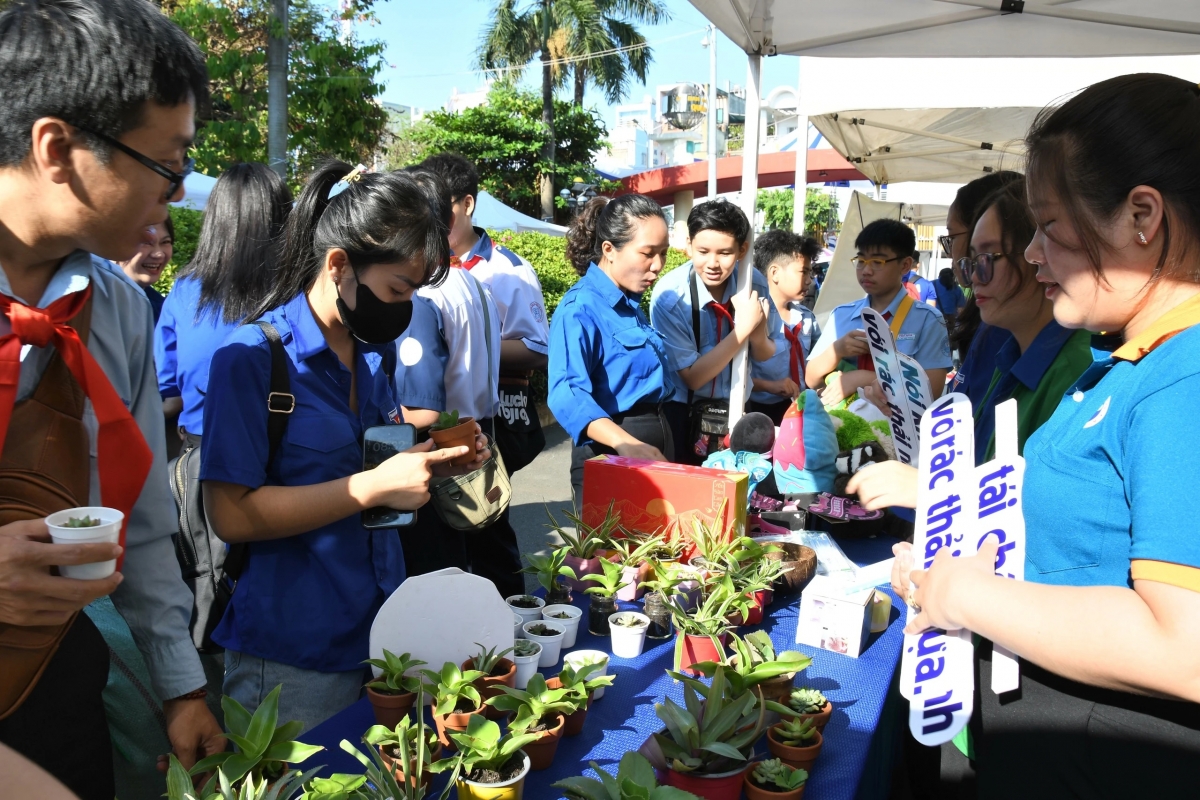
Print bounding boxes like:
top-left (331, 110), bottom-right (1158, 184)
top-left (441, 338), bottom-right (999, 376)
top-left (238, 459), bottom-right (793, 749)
top-left (908, 74), bottom-right (1200, 798)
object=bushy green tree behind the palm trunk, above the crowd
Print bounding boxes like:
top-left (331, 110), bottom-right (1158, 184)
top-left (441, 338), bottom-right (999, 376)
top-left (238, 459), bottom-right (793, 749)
top-left (388, 84), bottom-right (608, 216)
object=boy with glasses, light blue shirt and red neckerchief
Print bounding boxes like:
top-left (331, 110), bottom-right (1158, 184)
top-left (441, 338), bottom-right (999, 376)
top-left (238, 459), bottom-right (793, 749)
top-left (804, 219), bottom-right (953, 408)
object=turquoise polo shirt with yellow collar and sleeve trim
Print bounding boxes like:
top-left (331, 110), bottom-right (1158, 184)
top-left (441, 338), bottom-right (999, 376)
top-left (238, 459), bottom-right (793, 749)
top-left (1025, 316), bottom-right (1200, 587)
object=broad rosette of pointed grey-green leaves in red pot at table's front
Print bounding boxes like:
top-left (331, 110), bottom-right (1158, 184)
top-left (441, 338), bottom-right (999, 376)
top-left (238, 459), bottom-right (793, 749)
top-left (654, 667), bottom-right (766, 775)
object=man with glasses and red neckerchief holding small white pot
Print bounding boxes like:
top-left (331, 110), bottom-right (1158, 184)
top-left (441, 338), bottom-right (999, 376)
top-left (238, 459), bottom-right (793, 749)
top-left (0, 0), bottom-right (224, 800)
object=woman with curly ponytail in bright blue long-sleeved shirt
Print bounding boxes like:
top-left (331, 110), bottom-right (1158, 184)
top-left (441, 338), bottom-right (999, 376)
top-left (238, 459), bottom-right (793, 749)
top-left (547, 194), bottom-right (674, 509)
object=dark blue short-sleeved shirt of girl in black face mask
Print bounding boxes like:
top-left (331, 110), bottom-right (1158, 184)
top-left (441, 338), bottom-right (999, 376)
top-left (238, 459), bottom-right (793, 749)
top-left (200, 294), bottom-right (404, 672)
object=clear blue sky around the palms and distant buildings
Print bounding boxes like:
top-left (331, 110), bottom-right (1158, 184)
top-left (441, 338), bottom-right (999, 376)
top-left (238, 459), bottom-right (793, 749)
top-left (361, 0), bottom-right (799, 125)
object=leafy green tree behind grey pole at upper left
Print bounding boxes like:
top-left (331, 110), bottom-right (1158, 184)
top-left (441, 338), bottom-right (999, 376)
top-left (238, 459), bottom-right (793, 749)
top-left (162, 0), bottom-right (388, 182)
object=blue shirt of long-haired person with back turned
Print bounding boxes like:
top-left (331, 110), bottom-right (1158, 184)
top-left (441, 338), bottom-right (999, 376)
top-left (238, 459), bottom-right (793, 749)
top-left (154, 277), bottom-right (246, 435)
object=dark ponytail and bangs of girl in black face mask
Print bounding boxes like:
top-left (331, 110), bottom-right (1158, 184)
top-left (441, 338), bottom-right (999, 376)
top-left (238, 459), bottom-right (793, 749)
top-left (253, 161), bottom-right (450, 319)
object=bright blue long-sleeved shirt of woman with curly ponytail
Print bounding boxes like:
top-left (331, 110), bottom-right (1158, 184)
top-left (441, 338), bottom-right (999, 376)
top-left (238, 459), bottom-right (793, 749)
top-left (546, 264), bottom-right (674, 445)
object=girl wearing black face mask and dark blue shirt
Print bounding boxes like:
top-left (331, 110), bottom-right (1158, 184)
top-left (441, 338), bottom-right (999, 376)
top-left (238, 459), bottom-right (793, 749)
top-left (200, 162), bottom-right (487, 729)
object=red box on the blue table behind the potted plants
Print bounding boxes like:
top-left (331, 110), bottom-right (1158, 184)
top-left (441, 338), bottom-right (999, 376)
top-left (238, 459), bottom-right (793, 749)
top-left (582, 456), bottom-right (750, 537)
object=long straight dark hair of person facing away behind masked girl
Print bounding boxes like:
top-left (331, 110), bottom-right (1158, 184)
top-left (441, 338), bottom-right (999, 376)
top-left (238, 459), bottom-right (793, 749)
top-left (180, 163), bottom-right (292, 324)
